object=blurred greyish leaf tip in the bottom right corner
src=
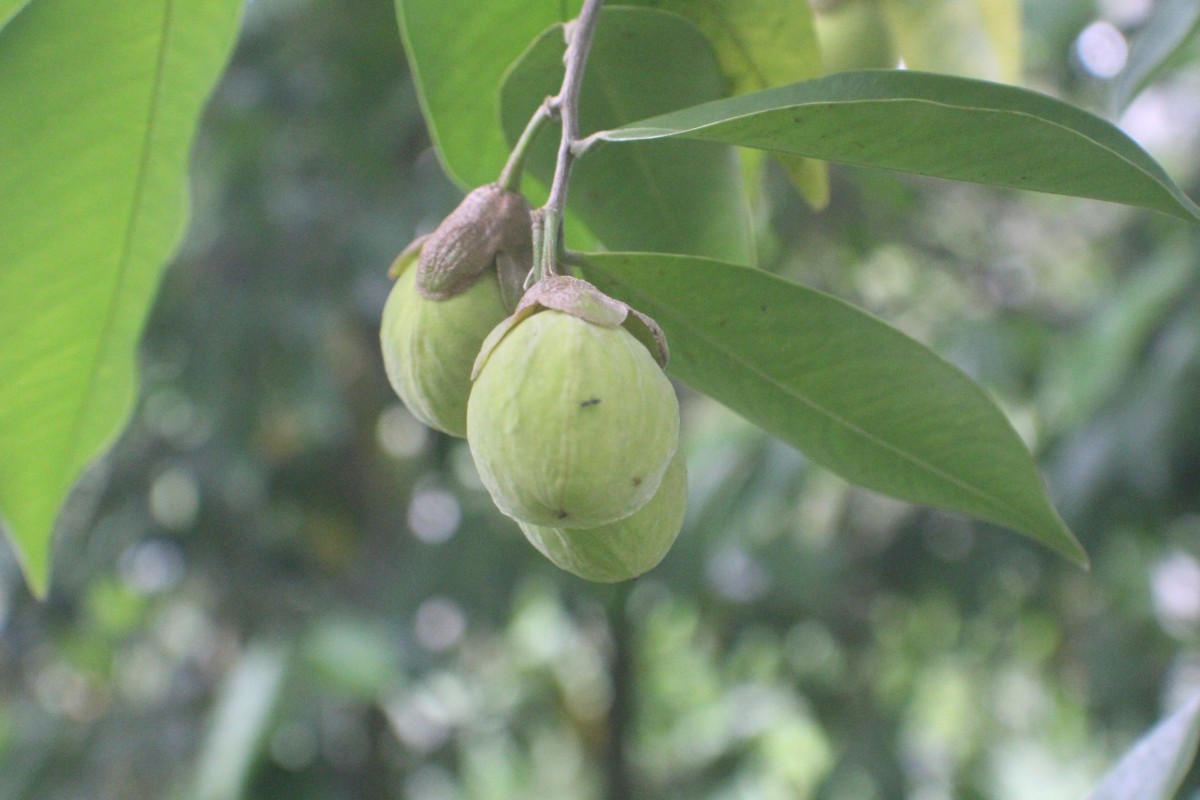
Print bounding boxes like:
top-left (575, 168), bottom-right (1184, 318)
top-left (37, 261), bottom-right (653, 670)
top-left (1087, 697), bottom-right (1200, 800)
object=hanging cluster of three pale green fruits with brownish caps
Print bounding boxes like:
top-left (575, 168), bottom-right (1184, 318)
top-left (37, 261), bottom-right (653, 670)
top-left (380, 185), bottom-right (686, 582)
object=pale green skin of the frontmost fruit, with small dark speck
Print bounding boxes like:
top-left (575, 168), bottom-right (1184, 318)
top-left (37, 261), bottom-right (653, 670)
top-left (467, 309), bottom-right (679, 528)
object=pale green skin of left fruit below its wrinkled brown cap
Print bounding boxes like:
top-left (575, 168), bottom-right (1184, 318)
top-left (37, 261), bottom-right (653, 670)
top-left (379, 269), bottom-right (508, 437)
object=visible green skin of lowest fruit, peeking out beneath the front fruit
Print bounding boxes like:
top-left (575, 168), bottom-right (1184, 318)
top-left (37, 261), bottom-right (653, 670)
top-left (518, 451), bottom-right (688, 583)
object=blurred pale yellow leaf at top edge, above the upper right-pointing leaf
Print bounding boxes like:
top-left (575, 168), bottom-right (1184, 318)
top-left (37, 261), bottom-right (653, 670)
top-left (882, 0), bottom-right (1021, 83)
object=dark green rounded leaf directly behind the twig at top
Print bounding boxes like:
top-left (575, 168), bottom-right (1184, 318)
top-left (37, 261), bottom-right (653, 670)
top-left (500, 7), bottom-right (750, 261)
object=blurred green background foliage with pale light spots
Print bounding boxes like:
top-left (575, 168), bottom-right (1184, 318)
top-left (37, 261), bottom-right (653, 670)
top-left (0, 0), bottom-right (1200, 800)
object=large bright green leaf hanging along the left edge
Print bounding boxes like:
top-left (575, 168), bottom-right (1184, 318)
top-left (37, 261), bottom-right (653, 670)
top-left (0, 0), bottom-right (241, 594)
